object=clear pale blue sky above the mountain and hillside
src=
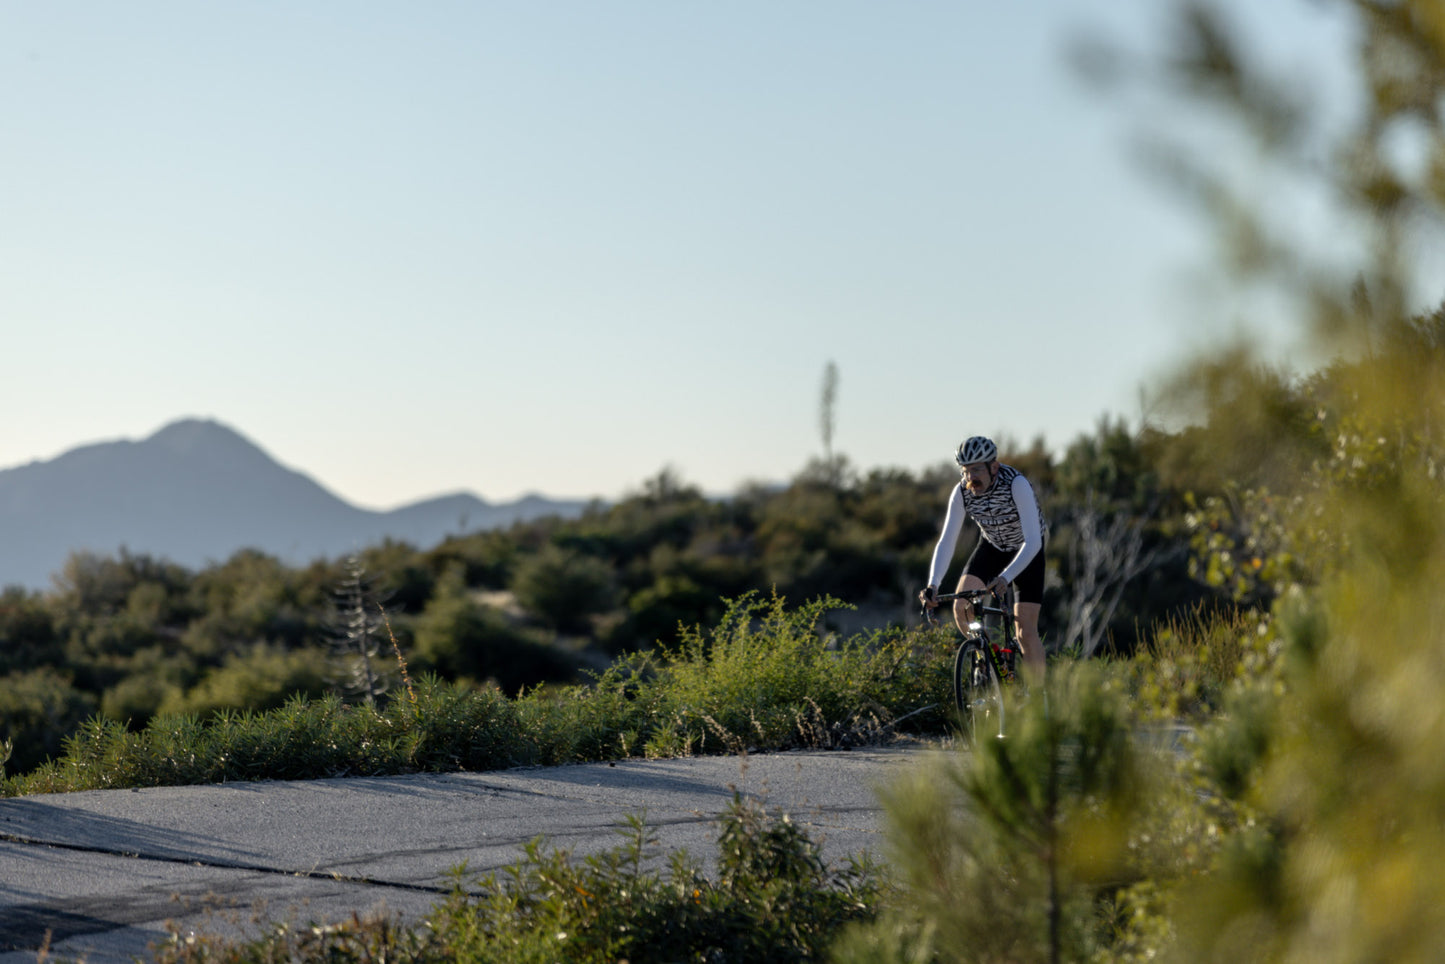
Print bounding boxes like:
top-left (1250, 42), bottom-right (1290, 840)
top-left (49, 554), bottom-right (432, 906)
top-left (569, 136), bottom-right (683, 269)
top-left (0, 0), bottom-right (1352, 507)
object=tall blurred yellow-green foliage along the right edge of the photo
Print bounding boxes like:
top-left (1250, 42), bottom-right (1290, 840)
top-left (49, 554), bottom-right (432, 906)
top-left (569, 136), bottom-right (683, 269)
top-left (1086, 0), bottom-right (1445, 961)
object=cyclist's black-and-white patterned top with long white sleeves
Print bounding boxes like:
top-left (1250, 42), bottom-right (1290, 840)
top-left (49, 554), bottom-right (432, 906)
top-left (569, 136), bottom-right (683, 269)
top-left (928, 465), bottom-right (1049, 588)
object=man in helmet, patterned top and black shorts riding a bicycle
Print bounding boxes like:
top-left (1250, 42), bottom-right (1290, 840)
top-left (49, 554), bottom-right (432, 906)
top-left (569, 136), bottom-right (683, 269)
top-left (918, 435), bottom-right (1049, 679)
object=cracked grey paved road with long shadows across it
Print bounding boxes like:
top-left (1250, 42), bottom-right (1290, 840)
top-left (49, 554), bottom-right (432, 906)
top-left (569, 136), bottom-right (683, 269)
top-left (0, 747), bottom-right (918, 964)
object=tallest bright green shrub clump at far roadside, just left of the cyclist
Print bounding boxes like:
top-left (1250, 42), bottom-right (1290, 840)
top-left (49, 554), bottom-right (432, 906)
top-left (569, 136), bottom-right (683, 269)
top-left (522, 594), bottom-right (951, 762)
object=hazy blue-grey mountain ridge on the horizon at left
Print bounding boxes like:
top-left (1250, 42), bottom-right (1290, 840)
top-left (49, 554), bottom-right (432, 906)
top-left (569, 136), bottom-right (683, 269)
top-left (0, 419), bottom-right (587, 588)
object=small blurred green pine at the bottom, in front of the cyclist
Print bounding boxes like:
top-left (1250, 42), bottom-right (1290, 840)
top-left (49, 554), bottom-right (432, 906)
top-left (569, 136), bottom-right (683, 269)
top-left (841, 663), bottom-right (1157, 964)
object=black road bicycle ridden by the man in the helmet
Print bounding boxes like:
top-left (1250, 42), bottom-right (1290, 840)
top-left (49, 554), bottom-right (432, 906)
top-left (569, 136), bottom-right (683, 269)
top-left (923, 588), bottom-right (1022, 741)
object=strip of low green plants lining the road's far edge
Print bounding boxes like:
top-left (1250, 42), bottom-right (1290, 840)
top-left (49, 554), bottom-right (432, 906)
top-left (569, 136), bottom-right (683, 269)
top-left (3, 595), bottom-right (948, 795)
